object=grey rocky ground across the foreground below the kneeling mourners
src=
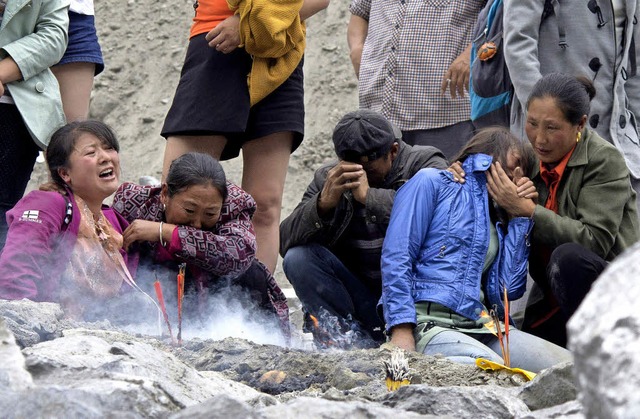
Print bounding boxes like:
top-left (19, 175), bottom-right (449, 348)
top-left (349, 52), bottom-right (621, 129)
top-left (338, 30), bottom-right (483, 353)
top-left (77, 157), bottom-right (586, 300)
top-left (0, 300), bottom-right (581, 418)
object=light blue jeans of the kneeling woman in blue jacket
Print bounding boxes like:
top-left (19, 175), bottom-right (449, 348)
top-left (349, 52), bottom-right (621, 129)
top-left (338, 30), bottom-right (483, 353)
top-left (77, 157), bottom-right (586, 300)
top-left (424, 328), bottom-right (573, 373)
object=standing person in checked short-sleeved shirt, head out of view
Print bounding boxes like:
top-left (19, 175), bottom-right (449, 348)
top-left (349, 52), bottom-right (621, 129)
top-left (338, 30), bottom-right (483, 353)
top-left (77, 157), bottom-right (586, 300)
top-left (347, 0), bottom-right (486, 158)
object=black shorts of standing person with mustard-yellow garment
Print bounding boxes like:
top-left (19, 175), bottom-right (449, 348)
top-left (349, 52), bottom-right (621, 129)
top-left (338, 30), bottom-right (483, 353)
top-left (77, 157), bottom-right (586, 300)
top-left (161, 34), bottom-right (304, 160)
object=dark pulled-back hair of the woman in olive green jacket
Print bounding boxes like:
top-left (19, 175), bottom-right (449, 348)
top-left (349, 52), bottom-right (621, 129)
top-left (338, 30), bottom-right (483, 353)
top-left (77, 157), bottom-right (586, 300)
top-left (527, 73), bottom-right (596, 125)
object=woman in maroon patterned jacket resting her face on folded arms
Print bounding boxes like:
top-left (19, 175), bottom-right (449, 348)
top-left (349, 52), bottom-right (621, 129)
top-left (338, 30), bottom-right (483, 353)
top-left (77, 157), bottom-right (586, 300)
top-left (113, 153), bottom-right (289, 336)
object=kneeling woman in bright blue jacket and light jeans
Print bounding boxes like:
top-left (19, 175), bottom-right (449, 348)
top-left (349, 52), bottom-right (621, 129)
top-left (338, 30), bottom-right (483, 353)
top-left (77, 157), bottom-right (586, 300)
top-left (381, 128), bottom-right (571, 372)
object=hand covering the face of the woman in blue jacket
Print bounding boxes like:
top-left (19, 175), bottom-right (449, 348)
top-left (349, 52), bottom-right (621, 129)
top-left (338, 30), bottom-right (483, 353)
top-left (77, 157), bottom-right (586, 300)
top-left (487, 163), bottom-right (537, 217)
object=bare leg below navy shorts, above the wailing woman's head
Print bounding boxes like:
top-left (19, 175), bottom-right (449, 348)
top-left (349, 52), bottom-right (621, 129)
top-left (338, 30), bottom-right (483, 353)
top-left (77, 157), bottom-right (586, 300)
top-left (51, 63), bottom-right (96, 122)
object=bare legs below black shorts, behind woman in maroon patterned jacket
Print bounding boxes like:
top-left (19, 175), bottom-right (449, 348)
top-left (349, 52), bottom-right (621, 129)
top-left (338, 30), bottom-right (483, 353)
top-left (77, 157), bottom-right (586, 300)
top-left (162, 132), bottom-right (293, 272)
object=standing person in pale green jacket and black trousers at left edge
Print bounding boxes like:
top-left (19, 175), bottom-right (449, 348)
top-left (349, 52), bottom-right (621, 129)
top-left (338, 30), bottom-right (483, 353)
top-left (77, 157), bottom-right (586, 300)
top-left (0, 0), bottom-right (69, 250)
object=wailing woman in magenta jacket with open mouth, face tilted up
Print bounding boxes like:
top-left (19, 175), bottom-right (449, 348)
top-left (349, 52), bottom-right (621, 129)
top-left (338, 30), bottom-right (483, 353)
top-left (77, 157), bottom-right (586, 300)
top-left (0, 121), bottom-right (135, 319)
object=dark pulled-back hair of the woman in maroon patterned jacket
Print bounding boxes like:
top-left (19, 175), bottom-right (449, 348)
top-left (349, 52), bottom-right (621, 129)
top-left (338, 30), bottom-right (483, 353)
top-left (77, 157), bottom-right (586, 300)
top-left (165, 152), bottom-right (227, 200)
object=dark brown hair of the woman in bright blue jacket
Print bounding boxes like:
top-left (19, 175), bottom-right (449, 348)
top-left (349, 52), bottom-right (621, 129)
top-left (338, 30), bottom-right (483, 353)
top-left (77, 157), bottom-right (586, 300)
top-left (452, 126), bottom-right (536, 176)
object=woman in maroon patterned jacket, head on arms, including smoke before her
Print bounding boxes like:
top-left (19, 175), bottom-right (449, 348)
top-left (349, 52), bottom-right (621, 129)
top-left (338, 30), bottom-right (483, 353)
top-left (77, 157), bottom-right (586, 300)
top-left (113, 152), bottom-right (289, 343)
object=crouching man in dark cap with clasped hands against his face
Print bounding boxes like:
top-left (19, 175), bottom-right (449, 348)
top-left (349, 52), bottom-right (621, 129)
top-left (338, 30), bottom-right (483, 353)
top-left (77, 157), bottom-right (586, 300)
top-left (280, 109), bottom-right (447, 348)
